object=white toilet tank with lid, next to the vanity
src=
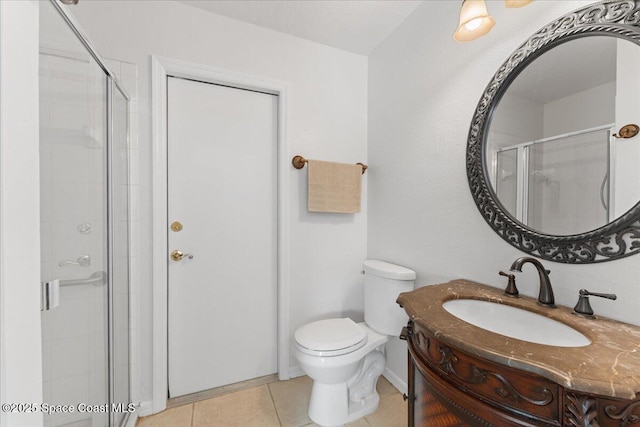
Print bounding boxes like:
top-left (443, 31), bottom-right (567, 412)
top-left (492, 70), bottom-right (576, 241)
top-left (363, 259), bottom-right (416, 337)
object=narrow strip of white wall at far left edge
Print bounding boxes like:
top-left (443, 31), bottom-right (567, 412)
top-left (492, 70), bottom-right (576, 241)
top-left (0, 1), bottom-right (42, 426)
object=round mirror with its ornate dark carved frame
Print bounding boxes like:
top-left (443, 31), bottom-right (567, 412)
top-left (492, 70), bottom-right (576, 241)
top-left (467, 0), bottom-right (640, 263)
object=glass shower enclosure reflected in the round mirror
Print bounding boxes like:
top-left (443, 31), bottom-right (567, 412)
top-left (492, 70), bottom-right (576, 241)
top-left (493, 125), bottom-right (614, 235)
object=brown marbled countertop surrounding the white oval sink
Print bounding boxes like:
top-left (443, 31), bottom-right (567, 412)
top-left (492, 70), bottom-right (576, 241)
top-left (397, 279), bottom-right (640, 399)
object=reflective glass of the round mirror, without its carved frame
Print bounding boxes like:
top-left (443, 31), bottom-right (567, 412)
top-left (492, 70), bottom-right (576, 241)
top-left (485, 36), bottom-right (640, 236)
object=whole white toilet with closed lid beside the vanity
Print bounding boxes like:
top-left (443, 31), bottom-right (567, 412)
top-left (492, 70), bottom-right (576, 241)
top-left (295, 260), bottom-right (416, 427)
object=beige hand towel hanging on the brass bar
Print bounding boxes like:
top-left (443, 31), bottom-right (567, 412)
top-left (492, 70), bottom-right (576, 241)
top-left (307, 160), bottom-right (362, 213)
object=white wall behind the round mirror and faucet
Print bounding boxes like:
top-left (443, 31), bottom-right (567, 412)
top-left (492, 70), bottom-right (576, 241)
top-left (367, 1), bottom-right (640, 384)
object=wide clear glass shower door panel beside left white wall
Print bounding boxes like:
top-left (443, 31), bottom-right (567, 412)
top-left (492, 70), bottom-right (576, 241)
top-left (40, 2), bottom-right (110, 426)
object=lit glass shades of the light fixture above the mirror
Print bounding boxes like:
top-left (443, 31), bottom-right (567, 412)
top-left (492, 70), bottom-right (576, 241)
top-left (453, 0), bottom-right (532, 43)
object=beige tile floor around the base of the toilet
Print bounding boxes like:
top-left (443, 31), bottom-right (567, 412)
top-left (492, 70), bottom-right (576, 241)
top-left (137, 376), bottom-right (407, 427)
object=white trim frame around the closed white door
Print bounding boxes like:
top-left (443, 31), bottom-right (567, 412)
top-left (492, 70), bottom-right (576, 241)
top-left (151, 55), bottom-right (290, 413)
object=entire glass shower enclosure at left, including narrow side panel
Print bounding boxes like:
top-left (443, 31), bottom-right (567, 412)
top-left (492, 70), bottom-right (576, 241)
top-left (39, 0), bottom-right (134, 426)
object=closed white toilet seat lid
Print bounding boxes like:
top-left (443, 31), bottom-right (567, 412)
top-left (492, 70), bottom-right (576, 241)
top-left (295, 317), bottom-right (367, 357)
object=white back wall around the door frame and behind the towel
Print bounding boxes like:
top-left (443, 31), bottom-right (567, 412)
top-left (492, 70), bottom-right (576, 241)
top-left (72, 1), bottom-right (368, 408)
